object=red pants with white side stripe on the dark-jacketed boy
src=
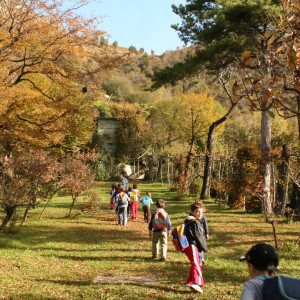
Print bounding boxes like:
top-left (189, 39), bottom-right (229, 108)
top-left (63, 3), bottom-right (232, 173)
top-left (184, 245), bottom-right (204, 286)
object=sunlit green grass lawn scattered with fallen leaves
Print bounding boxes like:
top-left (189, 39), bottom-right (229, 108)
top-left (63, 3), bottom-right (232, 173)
top-left (0, 183), bottom-right (300, 300)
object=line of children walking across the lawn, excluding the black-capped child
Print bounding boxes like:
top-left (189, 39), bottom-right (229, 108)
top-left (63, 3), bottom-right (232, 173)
top-left (110, 177), bottom-right (209, 293)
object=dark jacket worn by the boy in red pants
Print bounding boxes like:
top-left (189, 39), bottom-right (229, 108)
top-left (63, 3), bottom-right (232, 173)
top-left (184, 216), bottom-right (208, 252)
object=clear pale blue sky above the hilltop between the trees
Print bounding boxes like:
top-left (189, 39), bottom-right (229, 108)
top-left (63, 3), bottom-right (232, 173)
top-left (75, 0), bottom-right (185, 54)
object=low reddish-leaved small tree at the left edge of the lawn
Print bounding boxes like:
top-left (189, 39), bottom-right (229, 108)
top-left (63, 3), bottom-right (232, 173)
top-left (0, 151), bottom-right (61, 231)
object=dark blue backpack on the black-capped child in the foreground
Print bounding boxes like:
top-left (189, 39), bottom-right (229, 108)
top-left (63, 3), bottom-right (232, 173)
top-left (263, 276), bottom-right (300, 300)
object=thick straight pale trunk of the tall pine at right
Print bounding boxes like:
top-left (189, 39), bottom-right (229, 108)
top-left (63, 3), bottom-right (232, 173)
top-left (261, 110), bottom-right (273, 214)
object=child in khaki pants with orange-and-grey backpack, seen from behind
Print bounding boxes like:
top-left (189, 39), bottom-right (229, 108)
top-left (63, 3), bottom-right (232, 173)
top-left (148, 199), bottom-right (172, 262)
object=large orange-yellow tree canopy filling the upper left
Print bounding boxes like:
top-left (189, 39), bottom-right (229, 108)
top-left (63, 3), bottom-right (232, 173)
top-left (0, 0), bottom-right (122, 153)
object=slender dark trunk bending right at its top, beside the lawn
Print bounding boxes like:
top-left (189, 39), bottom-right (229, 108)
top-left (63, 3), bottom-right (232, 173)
top-left (200, 102), bottom-right (237, 200)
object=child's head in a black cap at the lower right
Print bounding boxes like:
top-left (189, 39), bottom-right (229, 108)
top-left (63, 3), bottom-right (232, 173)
top-left (240, 243), bottom-right (279, 278)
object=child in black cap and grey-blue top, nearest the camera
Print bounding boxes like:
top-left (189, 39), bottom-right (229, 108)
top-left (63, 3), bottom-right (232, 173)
top-left (240, 243), bottom-right (279, 300)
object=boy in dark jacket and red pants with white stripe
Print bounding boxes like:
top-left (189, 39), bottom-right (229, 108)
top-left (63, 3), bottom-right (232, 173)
top-left (183, 201), bottom-right (208, 293)
